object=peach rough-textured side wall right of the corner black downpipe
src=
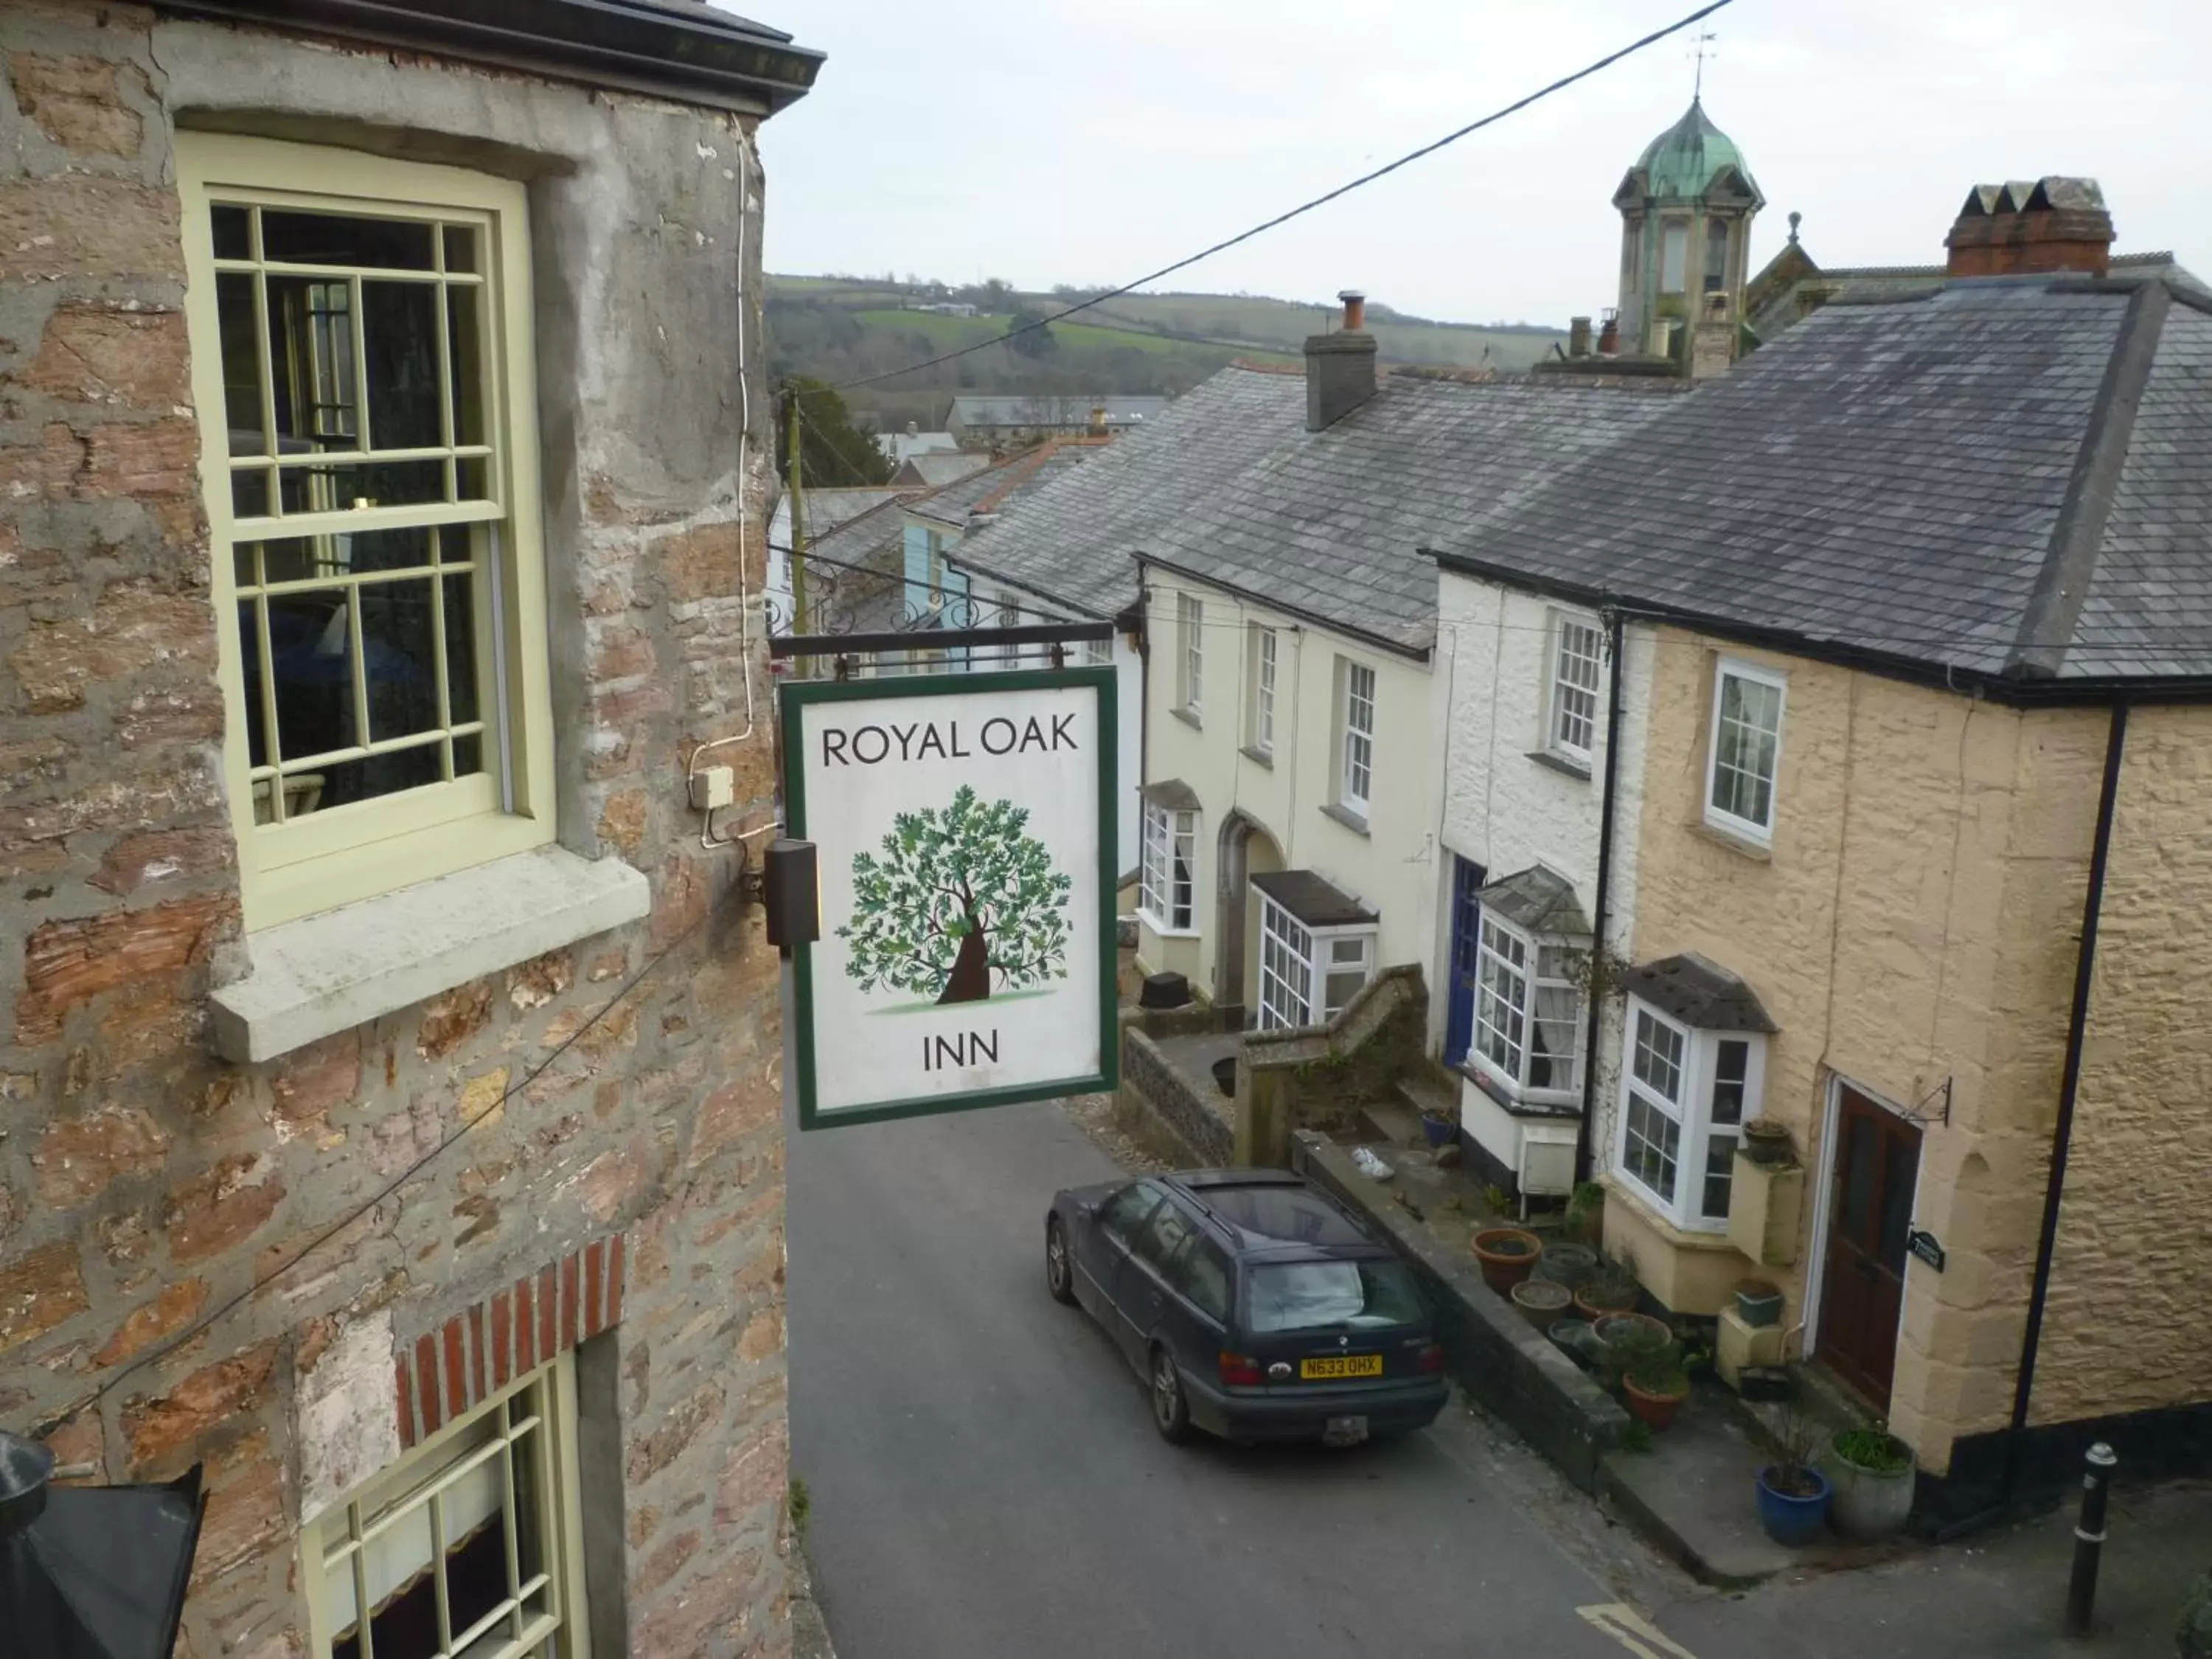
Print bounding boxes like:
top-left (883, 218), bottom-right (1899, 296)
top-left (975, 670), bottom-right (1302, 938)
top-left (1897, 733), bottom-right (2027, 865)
top-left (2028, 708), bottom-right (2212, 1422)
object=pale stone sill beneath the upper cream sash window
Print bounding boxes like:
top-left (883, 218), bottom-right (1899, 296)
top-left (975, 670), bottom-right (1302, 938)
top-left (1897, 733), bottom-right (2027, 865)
top-left (210, 847), bottom-right (653, 1064)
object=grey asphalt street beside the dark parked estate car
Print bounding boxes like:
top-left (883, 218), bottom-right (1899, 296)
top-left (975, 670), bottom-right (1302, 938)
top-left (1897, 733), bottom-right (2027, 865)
top-left (790, 1106), bottom-right (1672, 1659)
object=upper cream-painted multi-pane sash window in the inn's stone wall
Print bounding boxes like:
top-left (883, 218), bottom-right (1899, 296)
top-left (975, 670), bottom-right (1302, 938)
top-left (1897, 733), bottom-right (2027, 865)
top-left (177, 133), bottom-right (553, 927)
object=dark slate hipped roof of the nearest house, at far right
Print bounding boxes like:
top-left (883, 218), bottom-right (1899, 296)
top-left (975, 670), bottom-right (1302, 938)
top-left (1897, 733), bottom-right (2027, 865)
top-left (1433, 276), bottom-right (2212, 684)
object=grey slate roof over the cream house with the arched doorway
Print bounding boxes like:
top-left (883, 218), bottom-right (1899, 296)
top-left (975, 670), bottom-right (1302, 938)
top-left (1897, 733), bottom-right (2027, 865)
top-left (1144, 372), bottom-right (1694, 655)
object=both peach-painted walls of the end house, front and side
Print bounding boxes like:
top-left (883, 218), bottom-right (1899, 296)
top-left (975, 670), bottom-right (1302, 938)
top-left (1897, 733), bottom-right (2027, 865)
top-left (1599, 628), bottom-right (2212, 1475)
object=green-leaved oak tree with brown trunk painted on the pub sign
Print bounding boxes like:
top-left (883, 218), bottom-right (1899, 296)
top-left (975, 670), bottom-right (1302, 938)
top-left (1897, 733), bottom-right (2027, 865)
top-left (836, 785), bottom-right (1075, 1002)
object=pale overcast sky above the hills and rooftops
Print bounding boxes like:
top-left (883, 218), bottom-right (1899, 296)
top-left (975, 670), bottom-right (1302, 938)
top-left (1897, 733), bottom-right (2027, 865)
top-left (732, 0), bottom-right (2212, 325)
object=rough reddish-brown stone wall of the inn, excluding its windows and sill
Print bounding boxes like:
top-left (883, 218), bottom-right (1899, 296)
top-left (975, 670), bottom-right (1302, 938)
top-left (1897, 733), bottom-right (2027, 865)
top-left (0, 0), bottom-right (790, 1659)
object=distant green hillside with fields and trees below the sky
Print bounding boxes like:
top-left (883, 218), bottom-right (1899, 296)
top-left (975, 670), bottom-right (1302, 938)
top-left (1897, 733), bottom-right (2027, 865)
top-left (768, 276), bottom-right (1566, 429)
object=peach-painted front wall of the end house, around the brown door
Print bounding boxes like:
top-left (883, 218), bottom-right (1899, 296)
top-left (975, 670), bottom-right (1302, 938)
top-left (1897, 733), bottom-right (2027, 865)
top-left (1628, 628), bottom-right (2104, 1473)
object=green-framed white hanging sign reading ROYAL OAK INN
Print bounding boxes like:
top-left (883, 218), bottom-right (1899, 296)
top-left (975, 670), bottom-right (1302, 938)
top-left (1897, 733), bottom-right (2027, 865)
top-left (781, 668), bottom-right (1117, 1128)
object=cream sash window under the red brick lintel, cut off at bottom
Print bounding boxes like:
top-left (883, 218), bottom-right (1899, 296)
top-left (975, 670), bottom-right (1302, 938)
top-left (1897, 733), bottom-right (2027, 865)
top-left (301, 1354), bottom-right (588, 1659)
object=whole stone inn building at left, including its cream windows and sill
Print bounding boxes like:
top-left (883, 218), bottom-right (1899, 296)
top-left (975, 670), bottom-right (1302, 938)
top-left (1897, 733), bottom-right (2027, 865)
top-left (0, 0), bottom-right (818, 1659)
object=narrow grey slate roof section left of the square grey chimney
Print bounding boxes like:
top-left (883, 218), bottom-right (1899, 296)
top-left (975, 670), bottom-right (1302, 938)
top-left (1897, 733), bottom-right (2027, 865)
top-left (947, 367), bottom-right (1305, 619)
